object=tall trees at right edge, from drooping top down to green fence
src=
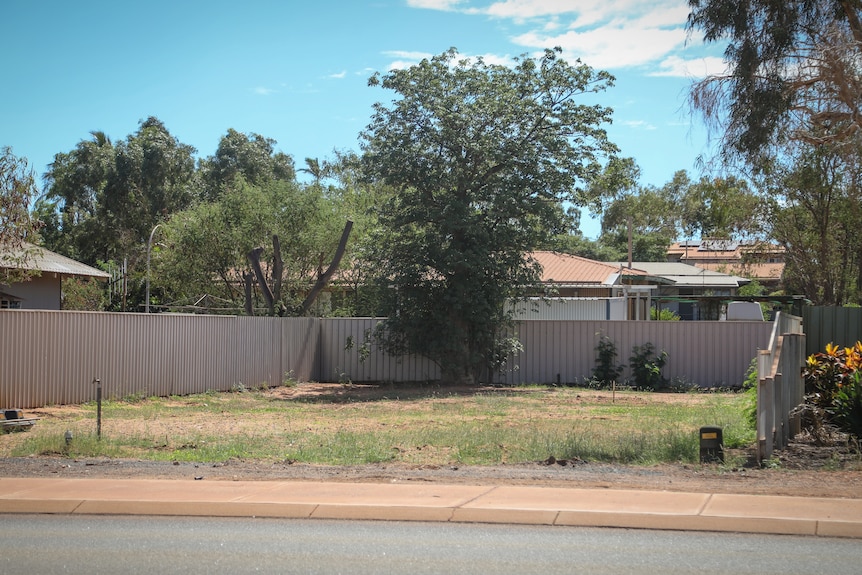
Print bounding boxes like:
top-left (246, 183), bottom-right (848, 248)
top-left (688, 0), bottom-right (862, 305)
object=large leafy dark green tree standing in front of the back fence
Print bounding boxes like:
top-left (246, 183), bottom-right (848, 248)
top-left (362, 49), bottom-right (617, 383)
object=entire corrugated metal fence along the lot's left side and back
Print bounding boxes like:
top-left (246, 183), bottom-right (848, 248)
top-left (0, 310), bottom-right (772, 408)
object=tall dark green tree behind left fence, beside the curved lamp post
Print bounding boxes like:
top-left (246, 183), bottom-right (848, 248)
top-left (45, 117), bottom-right (200, 311)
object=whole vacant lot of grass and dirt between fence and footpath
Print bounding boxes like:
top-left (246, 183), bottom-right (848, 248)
top-left (0, 384), bottom-right (862, 496)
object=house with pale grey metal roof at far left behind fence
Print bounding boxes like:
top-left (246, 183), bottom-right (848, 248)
top-left (0, 244), bottom-right (111, 310)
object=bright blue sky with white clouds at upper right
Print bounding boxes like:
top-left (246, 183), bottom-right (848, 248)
top-left (0, 0), bottom-right (723, 237)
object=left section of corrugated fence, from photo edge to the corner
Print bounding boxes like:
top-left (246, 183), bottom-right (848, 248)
top-left (0, 310), bottom-right (319, 408)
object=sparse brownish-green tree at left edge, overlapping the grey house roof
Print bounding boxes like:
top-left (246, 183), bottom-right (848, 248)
top-left (0, 147), bottom-right (40, 284)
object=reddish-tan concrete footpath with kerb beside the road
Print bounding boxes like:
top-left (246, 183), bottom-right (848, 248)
top-left (0, 478), bottom-right (862, 538)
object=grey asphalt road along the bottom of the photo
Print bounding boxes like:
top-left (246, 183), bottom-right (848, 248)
top-left (0, 515), bottom-right (862, 575)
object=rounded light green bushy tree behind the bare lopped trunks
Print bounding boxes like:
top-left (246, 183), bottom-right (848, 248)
top-left (157, 178), bottom-right (352, 315)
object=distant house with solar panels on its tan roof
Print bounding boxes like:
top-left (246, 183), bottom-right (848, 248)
top-left (667, 238), bottom-right (785, 291)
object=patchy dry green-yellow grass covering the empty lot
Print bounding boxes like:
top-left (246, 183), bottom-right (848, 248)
top-left (0, 383), bottom-right (753, 465)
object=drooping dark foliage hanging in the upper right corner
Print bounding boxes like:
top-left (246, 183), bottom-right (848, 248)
top-left (688, 0), bottom-right (862, 166)
